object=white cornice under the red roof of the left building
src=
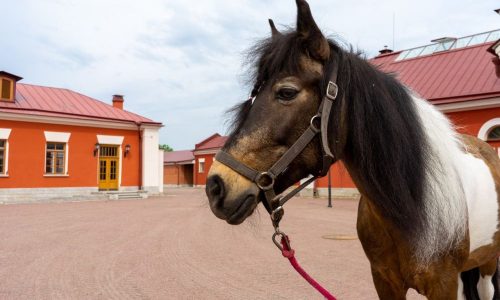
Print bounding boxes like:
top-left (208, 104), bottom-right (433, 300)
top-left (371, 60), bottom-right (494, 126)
top-left (0, 112), bottom-right (151, 130)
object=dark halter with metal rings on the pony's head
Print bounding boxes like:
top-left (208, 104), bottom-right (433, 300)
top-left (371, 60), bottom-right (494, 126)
top-left (215, 65), bottom-right (339, 229)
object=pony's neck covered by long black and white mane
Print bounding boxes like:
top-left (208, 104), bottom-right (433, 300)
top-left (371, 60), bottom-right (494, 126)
top-left (333, 54), bottom-right (466, 262)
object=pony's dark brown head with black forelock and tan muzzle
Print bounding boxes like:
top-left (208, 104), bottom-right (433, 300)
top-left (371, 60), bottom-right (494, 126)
top-left (206, 0), bottom-right (331, 224)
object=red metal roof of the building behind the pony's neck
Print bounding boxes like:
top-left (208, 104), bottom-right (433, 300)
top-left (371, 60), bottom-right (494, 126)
top-left (370, 42), bottom-right (500, 104)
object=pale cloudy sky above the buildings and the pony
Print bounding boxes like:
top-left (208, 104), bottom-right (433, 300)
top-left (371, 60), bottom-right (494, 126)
top-left (0, 0), bottom-right (500, 150)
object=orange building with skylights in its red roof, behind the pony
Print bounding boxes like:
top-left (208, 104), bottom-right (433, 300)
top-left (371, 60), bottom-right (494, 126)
top-left (314, 30), bottom-right (500, 196)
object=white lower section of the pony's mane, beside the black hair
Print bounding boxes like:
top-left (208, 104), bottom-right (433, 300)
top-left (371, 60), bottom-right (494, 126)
top-left (413, 96), bottom-right (469, 266)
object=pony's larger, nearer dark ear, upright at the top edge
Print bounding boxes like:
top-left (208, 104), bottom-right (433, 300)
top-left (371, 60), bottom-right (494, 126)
top-left (296, 0), bottom-right (330, 61)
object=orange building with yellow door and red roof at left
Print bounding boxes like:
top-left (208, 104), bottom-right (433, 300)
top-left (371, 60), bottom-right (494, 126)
top-left (0, 71), bottom-right (163, 202)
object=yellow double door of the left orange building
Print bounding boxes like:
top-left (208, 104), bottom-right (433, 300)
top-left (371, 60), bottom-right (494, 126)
top-left (99, 145), bottom-right (120, 190)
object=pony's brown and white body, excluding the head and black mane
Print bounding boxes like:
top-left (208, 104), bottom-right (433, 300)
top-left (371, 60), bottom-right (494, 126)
top-left (356, 97), bottom-right (500, 299)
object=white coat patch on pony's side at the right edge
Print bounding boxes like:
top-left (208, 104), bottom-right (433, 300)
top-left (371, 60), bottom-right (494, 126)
top-left (460, 154), bottom-right (499, 251)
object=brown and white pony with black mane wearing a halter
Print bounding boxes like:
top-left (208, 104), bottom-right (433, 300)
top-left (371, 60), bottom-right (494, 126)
top-left (206, 0), bottom-right (500, 299)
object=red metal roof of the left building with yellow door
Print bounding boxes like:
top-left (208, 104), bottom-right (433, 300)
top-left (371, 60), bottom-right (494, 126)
top-left (0, 83), bottom-right (161, 125)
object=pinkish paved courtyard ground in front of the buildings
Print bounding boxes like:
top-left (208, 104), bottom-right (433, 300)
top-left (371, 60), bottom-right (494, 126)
top-left (0, 189), bottom-right (420, 300)
